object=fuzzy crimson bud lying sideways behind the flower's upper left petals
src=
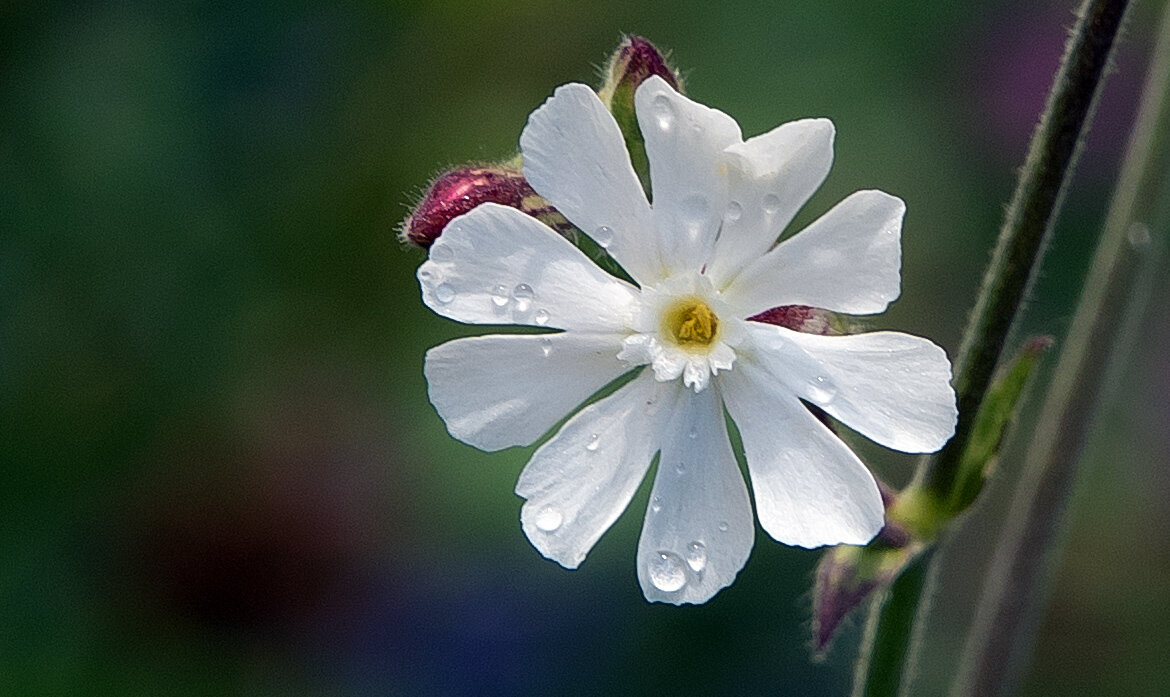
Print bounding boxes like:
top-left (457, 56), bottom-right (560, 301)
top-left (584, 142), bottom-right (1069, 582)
top-left (399, 165), bottom-right (572, 249)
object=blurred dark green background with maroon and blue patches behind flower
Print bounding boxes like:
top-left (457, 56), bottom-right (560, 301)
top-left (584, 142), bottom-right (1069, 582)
top-left (0, 0), bottom-right (1170, 696)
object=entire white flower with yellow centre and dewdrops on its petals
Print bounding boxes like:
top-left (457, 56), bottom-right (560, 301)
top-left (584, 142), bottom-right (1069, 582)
top-left (418, 77), bottom-right (956, 603)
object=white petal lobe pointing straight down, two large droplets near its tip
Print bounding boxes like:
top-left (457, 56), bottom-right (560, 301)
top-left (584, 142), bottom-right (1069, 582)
top-left (638, 389), bottom-right (755, 605)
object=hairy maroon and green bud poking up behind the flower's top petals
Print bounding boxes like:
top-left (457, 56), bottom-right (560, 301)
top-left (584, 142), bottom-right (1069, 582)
top-left (598, 36), bottom-right (682, 185)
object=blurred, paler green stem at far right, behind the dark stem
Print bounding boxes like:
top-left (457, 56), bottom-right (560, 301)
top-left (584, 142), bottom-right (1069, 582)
top-left (952, 2), bottom-right (1170, 697)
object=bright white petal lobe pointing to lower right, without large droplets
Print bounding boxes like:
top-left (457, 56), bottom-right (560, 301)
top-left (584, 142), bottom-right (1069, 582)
top-left (720, 357), bottom-right (885, 547)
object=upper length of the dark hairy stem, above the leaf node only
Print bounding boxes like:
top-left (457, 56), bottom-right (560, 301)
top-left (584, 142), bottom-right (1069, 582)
top-left (918, 0), bottom-right (1129, 496)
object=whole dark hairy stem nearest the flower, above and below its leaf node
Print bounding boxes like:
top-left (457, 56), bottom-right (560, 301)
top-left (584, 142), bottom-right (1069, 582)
top-left (854, 0), bottom-right (1129, 697)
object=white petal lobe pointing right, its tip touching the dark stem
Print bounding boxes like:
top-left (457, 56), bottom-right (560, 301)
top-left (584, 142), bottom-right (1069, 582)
top-left (748, 322), bottom-right (958, 453)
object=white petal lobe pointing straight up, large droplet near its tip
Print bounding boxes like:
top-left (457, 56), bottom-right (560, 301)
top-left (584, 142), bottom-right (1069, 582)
top-left (634, 76), bottom-right (741, 272)
